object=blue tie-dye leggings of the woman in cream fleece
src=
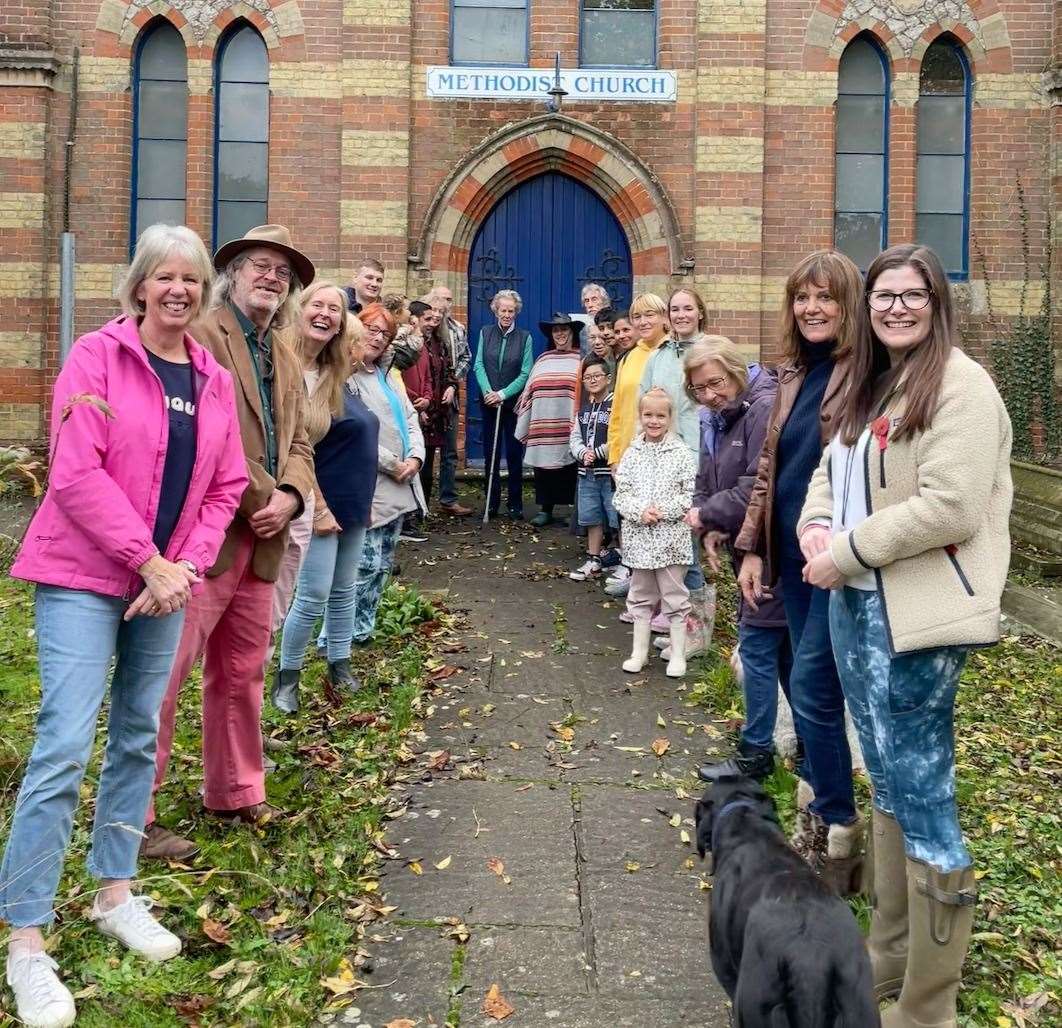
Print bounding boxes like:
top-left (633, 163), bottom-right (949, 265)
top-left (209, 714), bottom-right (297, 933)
top-left (829, 588), bottom-right (972, 872)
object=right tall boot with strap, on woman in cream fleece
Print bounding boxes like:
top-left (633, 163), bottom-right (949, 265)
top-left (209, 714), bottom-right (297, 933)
top-left (881, 858), bottom-right (977, 1028)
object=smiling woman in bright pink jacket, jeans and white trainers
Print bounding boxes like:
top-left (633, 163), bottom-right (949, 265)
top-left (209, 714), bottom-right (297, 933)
top-left (0, 225), bottom-right (247, 1028)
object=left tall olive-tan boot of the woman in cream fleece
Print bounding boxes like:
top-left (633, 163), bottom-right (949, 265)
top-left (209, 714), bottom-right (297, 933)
top-left (867, 808), bottom-right (907, 1003)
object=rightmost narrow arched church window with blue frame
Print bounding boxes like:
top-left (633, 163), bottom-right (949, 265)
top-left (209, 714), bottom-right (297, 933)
top-left (915, 38), bottom-right (971, 278)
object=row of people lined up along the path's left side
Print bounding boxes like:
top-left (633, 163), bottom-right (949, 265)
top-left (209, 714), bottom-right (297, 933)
top-left (0, 225), bottom-right (482, 1028)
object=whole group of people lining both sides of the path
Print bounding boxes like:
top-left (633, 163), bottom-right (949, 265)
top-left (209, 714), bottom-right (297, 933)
top-left (0, 225), bottom-right (1012, 1028)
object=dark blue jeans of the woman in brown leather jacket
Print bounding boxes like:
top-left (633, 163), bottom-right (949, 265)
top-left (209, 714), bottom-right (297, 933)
top-left (781, 556), bottom-right (856, 824)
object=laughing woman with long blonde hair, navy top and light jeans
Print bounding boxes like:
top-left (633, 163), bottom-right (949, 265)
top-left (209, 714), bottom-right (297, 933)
top-left (271, 282), bottom-right (379, 714)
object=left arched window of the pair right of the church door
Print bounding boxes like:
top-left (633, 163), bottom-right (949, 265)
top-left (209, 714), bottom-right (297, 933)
top-left (834, 36), bottom-right (889, 268)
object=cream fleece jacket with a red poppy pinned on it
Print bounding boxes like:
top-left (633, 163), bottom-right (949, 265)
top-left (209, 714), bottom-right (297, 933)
top-left (798, 349), bottom-right (1013, 653)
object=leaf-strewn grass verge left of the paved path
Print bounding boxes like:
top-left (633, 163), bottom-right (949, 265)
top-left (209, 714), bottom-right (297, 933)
top-left (0, 580), bottom-right (449, 1028)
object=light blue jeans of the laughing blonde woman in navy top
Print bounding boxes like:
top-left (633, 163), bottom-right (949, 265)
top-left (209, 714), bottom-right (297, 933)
top-left (280, 528), bottom-right (365, 671)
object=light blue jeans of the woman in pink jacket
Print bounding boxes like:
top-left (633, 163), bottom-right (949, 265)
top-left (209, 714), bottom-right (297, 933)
top-left (0, 585), bottom-right (185, 928)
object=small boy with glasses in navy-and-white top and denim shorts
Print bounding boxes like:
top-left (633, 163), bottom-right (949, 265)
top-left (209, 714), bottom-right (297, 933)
top-left (568, 357), bottom-right (619, 582)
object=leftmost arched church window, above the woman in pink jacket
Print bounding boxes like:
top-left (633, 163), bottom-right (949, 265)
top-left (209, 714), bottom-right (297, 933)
top-left (130, 21), bottom-right (188, 250)
